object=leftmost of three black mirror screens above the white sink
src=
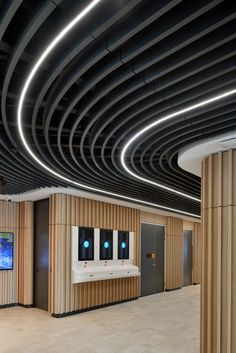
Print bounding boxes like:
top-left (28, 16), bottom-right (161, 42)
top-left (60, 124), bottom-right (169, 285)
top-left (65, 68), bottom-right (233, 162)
top-left (79, 227), bottom-right (94, 261)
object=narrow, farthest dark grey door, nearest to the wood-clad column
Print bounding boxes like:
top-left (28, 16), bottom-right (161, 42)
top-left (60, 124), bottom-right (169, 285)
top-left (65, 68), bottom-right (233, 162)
top-left (184, 230), bottom-right (192, 287)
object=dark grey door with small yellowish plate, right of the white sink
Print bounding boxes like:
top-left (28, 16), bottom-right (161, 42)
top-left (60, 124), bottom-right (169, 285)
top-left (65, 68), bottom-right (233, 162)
top-left (141, 224), bottom-right (165, 296)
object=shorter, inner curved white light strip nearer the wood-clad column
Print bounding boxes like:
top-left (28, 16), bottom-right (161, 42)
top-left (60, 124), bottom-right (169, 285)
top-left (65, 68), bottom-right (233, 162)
top-left (120, 89), bottom-right (236, 202)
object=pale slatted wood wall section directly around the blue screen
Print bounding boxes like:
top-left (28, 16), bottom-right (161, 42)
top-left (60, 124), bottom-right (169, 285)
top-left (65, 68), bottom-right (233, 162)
top-left (0, 201), bottom-right (19, 305)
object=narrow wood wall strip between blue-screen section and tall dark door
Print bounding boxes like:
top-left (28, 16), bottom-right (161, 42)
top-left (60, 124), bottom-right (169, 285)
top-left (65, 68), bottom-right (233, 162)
top-left (18, 201), bottom-right (33, 305)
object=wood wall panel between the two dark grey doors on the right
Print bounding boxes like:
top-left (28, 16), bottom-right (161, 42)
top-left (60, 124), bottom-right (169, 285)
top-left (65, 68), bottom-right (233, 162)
top-left (166, 217), bottom-right (183, 290)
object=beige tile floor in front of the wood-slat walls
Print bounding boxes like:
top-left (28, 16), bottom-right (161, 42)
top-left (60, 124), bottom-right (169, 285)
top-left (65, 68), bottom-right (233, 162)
top-left (0, 286), bottom-right (200, 353)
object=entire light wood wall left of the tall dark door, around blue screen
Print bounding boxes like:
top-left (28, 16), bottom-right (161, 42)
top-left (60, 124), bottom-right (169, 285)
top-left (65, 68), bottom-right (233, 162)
top-left (0, 201), bottom-right (33, 305)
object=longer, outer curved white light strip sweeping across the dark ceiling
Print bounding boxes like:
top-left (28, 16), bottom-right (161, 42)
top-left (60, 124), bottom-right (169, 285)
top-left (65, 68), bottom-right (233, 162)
top-left (17, 0), bottom-right (200, 218)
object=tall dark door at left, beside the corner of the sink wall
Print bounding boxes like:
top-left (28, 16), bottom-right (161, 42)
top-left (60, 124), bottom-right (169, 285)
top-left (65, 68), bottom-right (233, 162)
top-left (34, 199), bottom-right (49, 310)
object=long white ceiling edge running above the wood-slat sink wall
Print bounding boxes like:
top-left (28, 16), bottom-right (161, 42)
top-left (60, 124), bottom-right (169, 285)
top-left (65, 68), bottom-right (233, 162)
top-left (0, 187), bottom-right (201, 223)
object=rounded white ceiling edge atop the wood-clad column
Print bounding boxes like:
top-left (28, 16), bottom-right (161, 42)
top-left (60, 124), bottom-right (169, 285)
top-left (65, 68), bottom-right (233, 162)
top-left (178, 131), bottom-right (236, 177)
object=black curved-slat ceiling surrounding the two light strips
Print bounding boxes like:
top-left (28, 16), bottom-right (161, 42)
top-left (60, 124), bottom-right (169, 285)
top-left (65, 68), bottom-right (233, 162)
top-left (0, 0), bottom-right (236, 214)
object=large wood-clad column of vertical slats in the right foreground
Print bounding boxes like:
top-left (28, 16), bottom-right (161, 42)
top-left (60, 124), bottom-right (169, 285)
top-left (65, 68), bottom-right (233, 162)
top-left (201, 150), bottom-right (236, 353)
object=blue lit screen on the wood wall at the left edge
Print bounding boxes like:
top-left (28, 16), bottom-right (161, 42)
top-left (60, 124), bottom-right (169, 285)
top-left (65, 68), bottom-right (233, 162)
top-left (0, 232), bottom-right (14, 270)
